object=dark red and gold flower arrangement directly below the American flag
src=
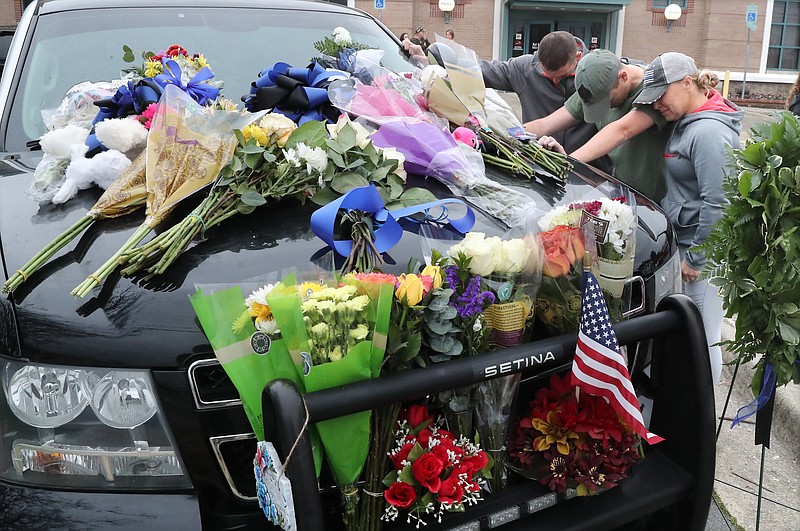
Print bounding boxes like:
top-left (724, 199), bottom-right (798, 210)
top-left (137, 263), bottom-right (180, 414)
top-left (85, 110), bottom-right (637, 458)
top-left (509, 373), bottom-right (641, 496)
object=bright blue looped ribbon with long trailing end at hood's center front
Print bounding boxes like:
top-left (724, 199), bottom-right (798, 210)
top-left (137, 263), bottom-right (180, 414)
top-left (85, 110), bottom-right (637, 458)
top-left (311, 184), bottom-right (475, 256)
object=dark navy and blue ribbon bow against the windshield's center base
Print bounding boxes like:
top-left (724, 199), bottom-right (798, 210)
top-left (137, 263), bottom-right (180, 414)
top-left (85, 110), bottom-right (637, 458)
top-left (242, 62), bottom-right (348, 124)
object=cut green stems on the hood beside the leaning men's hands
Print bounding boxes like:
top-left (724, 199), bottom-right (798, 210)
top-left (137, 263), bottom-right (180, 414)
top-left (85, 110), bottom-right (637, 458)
top-left (478, 129), bottom-right (572, 182)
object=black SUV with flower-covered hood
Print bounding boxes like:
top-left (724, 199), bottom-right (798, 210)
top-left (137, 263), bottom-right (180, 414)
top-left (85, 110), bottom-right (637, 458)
top-left (0, 0), bottom-right (680, 531)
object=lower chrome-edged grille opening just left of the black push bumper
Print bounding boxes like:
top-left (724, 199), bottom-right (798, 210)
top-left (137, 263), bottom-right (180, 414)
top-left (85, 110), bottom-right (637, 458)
top-left (209, 433), bottom-right (257, 501)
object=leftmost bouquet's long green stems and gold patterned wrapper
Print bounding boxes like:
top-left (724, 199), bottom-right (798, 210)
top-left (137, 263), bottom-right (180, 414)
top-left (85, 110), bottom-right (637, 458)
top-left (2, 153), bottom-right (147, 293)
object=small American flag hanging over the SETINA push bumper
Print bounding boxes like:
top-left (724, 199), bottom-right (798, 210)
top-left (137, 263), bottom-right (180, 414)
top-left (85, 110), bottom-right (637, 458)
top-left (572, 271), bottom-right (664, 444)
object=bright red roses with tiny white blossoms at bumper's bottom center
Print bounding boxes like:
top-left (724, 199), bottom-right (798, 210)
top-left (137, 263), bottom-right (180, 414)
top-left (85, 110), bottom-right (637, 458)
top-left (382, 406), bottom-right (491, 527)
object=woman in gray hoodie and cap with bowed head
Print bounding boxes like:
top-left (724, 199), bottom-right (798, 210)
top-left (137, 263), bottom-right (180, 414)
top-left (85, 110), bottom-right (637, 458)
top-left (635, 52), bottom-right (744, 382)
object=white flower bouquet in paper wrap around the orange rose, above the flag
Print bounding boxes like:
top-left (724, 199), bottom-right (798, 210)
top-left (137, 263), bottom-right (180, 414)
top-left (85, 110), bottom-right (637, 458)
top-left (539, 191), bottom-right (637, 299)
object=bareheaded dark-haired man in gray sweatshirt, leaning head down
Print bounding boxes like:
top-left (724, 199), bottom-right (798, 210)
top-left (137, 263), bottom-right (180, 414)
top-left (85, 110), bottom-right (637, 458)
top-left (481, 31), bottom-right (597, 159)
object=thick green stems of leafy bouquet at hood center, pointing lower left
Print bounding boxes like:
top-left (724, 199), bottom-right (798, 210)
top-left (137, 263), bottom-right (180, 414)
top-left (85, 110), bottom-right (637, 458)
top-left (119, 154), bottom-right (317, 278)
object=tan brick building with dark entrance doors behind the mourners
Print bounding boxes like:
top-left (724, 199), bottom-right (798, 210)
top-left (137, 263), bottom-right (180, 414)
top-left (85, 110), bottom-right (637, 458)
top-left (360, 0), bottom-right (800, 92)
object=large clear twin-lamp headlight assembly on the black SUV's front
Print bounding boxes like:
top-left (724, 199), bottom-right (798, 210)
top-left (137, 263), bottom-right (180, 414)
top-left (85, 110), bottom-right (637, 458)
top-left (0, 362), bottom-right (191, 490)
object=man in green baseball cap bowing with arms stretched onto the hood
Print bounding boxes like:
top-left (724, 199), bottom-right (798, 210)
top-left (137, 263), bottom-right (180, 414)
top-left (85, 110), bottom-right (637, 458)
top-left (525, 50), bottom-right (669, 201)
